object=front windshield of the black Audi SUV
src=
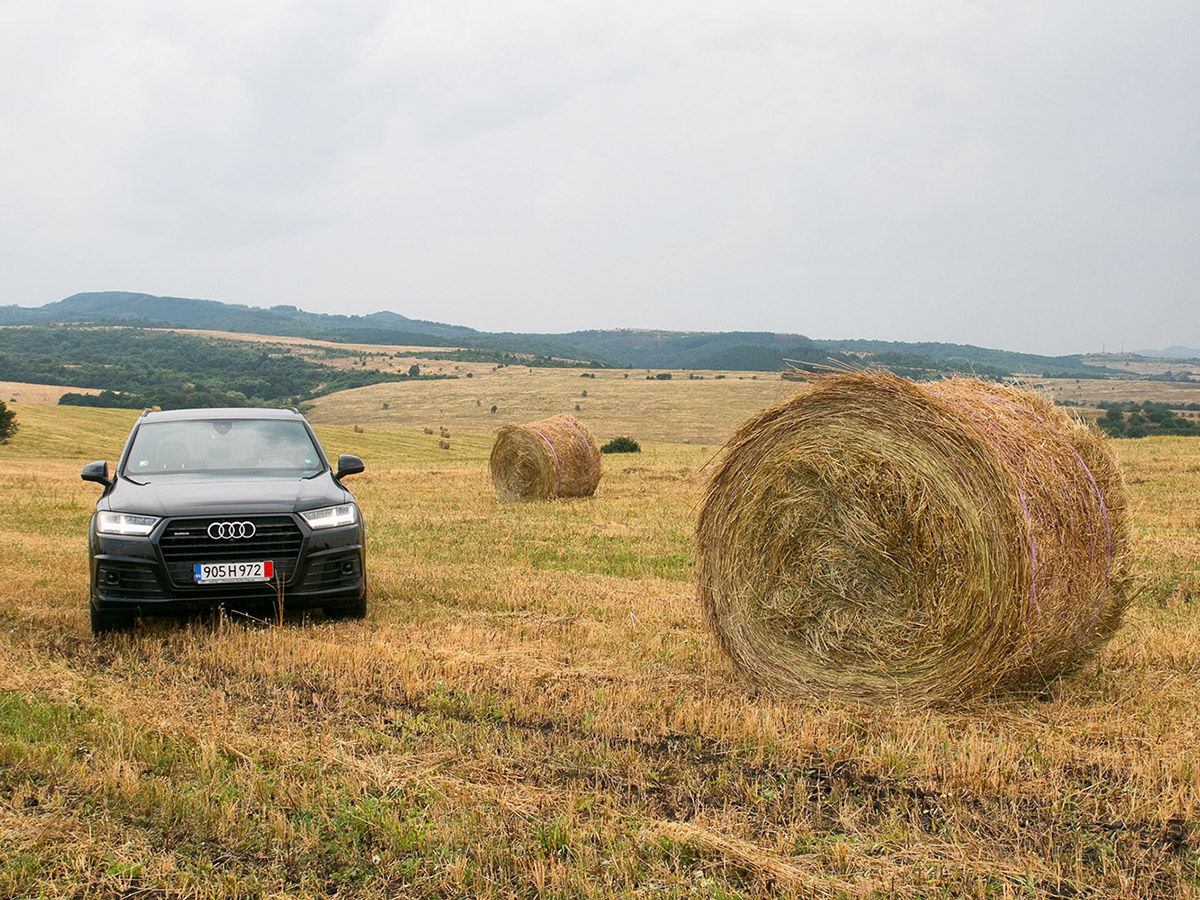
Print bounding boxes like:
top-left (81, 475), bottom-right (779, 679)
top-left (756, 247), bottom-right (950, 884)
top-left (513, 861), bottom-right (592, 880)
top-left (122, 419), bottom-right (324, 478)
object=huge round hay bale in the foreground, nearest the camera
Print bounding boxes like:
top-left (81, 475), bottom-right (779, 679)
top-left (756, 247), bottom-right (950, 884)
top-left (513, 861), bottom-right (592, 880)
top-left (696, 373), bottom-right (1129, 703)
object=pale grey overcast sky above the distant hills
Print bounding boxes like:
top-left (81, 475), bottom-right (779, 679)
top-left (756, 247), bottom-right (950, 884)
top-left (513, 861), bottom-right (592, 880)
top-left (0, 0), bottom-right (1200, 354)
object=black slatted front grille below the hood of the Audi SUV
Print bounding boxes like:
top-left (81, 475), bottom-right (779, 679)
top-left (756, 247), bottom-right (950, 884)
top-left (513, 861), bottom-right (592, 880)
top-left (158, 516), bottom-right (304, 588)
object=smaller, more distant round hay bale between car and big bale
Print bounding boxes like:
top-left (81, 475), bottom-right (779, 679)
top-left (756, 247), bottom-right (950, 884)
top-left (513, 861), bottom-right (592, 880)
top-left (490, 415), bottom-right (600, 500)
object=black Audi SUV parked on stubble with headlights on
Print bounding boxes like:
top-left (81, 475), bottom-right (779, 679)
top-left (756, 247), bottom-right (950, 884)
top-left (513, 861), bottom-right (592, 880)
top-left (79, 409), bottom-right (366, 634)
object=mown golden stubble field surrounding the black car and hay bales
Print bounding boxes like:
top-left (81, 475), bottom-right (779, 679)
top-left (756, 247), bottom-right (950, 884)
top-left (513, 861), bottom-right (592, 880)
top-left (0, 393), bottom-right (1200, 898)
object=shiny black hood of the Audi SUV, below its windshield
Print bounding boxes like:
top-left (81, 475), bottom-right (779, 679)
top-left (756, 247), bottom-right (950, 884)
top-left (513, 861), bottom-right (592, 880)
top-left (97, 472), bottom-right (353, 516)
